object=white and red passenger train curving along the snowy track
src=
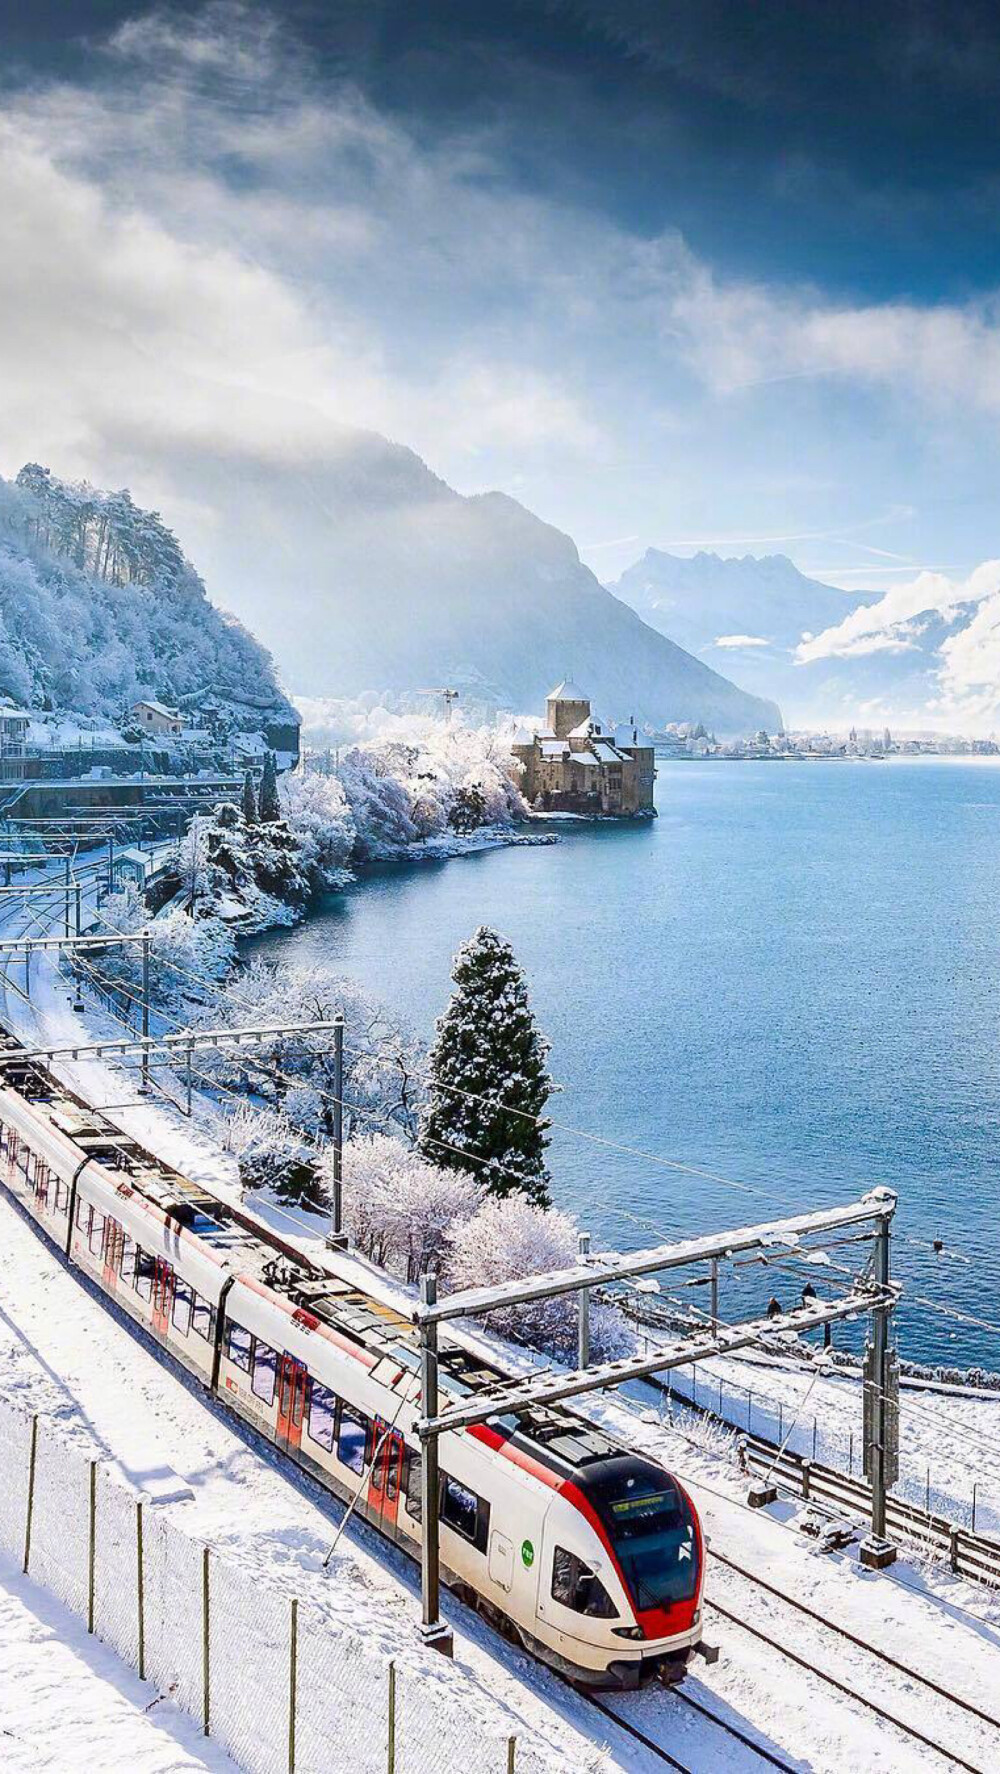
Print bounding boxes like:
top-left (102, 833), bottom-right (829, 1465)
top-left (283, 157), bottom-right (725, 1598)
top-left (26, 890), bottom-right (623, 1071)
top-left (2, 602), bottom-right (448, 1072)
top-left (0, 1032), bottom-right (706, 1689)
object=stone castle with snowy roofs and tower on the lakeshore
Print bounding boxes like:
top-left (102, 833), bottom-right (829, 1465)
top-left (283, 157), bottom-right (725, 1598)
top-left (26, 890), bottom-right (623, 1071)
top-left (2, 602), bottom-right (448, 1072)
top-left (512, 681), bottom-right (656, 820)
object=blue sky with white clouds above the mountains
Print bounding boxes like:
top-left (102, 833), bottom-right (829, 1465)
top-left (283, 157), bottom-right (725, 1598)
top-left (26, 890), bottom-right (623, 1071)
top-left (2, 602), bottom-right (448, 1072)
top-left (0, 0), bottom-right (1000, 610)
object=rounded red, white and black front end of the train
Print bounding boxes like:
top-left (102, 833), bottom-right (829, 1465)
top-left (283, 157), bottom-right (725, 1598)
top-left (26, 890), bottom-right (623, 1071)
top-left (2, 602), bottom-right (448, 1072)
top-left (539, 1453), bottom-right (704, 1689)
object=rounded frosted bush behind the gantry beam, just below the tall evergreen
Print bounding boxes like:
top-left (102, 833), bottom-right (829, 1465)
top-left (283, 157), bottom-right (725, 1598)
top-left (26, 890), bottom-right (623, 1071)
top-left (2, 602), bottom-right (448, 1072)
top-left (447, 1196), bottom-right (622, 1357)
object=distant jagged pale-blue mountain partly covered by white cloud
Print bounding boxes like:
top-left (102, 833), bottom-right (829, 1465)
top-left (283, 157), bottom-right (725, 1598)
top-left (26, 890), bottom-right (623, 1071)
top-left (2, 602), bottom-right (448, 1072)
top-left (610, 548), bottom-right (879, 726)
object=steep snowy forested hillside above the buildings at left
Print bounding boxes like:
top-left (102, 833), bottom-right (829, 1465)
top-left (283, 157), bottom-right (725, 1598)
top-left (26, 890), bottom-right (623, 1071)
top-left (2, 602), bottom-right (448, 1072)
top-left (0, 463), bottom-right (296, 747)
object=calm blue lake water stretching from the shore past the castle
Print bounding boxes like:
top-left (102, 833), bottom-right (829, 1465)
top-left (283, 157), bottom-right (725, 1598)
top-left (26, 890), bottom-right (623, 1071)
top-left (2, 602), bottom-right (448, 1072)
top-left (251, 759), bottom-right (1000, 1368)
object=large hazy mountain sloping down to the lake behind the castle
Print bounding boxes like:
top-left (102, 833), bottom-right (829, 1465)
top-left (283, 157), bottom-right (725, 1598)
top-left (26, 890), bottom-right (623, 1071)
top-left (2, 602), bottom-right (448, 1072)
top-left (173, 433), bottom-right (780, 734)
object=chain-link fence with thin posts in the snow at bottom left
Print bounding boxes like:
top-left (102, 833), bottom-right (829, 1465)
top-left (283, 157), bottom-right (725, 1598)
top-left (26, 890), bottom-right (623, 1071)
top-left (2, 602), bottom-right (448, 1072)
top-left (0, 1401), bottom-right (573, 1774)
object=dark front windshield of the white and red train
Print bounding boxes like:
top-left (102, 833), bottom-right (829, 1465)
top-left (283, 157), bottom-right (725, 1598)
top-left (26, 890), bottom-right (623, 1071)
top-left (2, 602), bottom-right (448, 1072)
top-left (594, 1464), bottom-right (699, 1609)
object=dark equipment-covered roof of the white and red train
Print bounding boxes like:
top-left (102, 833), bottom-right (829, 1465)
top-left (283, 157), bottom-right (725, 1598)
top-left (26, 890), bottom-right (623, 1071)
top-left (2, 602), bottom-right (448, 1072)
top-left (0, 1031), bottom-right (622, 1476)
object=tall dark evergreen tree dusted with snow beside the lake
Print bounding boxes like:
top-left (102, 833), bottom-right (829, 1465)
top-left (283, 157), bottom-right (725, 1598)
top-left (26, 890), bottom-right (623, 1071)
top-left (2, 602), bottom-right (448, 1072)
top-left (418, 926), bottom-right (551, 1206)
